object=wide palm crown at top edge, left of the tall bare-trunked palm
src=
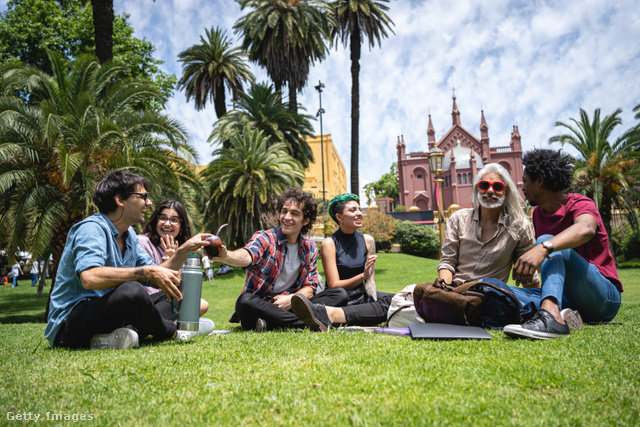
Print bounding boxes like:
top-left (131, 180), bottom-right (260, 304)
top-left (233, 0), bottom-right (335, 111)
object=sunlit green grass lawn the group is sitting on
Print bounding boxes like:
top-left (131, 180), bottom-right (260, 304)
top-left (0, 254), bottom-right (640, 426)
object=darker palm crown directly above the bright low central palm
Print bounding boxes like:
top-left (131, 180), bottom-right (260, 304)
top-left (209, 83), bottom-right (313, 169)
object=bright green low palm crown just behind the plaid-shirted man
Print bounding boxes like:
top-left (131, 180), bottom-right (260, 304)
top-left (201, 127), bottom-right (304, 247)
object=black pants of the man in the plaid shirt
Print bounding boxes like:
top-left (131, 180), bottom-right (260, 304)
top-left (236, 288), bottom-right (349, 329)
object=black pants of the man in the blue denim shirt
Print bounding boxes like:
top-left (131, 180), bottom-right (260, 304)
top-left (54, 282), bottom-right (176, 348)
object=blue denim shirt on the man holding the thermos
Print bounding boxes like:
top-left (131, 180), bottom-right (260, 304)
top-left (44, 213), bottom-right (155, 346)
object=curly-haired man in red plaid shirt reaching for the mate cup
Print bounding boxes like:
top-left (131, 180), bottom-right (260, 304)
top-left (213, 189), bottom-right (348, 332)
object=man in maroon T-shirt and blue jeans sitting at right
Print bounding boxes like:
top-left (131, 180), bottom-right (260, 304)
top-left (504, 149), bottom-right (622, 339)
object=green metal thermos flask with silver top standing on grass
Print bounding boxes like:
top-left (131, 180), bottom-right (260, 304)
top-left (178, 254), bottom-right (202, 335)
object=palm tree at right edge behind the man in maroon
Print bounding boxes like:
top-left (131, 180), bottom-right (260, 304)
top-left (549, 108), bottom-right (640, 241)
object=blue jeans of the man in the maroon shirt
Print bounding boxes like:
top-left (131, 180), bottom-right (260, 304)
top-left (510, 234), bottom-right (621, 322)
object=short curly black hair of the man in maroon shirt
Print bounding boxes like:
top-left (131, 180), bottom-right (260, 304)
top-left (522, 148), bottom-right (573, 191)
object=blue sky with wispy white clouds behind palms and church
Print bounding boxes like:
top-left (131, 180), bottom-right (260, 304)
top-left (0, 0), bottom-right (640, 197)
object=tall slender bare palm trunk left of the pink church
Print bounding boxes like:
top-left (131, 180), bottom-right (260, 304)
top-left (351, 25), bottom-right (362, 195)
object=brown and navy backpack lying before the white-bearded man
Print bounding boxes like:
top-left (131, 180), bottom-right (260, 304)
top-left (413, 279), bottom-right (535, 329)
